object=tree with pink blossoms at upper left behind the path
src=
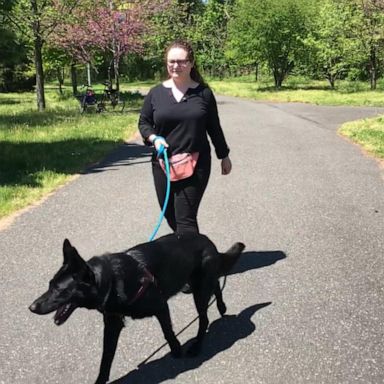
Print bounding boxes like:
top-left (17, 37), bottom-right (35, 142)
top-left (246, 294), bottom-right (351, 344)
top-left (51, 0), bottom-right (167, 89)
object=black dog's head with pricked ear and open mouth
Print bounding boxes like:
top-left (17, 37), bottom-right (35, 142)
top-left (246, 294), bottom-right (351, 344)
top-left (29, 239), bottom-right (95, 325)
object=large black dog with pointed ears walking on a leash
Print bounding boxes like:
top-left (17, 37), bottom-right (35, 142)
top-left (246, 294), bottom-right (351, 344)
top-left (29, 235), bottom-right (245, 384)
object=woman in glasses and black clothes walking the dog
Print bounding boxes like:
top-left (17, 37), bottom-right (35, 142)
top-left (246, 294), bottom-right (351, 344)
top-left (139, 40), bottom-right (232, 234)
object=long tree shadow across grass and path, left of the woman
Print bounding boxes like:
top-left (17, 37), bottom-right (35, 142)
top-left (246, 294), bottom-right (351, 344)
top-left (0, 137), bottom-right (152, 188)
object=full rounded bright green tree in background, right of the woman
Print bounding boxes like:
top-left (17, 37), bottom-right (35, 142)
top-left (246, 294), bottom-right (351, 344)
top-left (229, 0), bottom-right (310, 88)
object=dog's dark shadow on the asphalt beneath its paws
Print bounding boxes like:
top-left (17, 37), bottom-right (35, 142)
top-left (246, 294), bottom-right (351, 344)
top-left (113, 302), bottom-right (271, 384)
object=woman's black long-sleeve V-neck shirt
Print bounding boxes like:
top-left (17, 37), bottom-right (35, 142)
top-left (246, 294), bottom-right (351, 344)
top-left (139, 84), bottom-right (229, 159)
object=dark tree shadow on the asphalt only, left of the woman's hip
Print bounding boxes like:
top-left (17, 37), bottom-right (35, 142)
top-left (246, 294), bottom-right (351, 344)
top-left (86, 143), bottom-right (153, 173)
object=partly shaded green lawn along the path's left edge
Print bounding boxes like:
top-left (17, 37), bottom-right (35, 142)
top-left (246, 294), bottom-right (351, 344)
top-left (0, 89), bottom-right (142, 218)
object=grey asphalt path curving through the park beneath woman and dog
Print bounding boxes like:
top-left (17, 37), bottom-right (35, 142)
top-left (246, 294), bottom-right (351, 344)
top-left (0, 97), bottom-right (384, 384)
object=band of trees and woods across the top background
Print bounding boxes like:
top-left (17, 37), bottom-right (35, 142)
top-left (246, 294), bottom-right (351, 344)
top-left (0, 0), bottom-right (384, 110)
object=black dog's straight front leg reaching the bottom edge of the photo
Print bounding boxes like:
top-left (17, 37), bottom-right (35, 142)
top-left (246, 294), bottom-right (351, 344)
top-left (95, 314), bottom-right (124, 384)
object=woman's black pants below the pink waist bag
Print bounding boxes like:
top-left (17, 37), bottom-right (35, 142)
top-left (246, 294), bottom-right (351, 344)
top-left (152, 156), bottom-right (211, 233)
